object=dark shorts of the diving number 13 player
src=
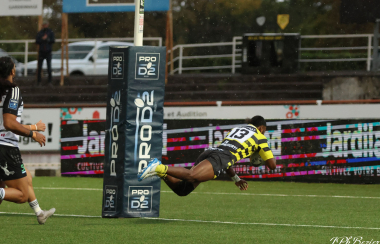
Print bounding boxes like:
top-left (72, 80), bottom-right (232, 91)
top-left (195, 148), bottom-right (232, 179)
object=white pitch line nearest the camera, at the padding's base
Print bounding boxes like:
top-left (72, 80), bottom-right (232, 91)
top-left (0, 212), bottom-right (380, 230)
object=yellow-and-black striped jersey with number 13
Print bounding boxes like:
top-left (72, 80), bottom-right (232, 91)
top-left (218, 124), bottom-right (273, 164)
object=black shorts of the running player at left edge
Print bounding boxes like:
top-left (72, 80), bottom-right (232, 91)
top-left (0, 145), bottom-right (26, 181)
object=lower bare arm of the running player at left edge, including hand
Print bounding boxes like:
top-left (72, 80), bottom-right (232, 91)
top-left (3, 113), bottom-right (46, 147)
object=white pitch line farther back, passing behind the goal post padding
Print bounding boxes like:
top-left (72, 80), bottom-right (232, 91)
top-left (34, 187), bottom-right (380, 199)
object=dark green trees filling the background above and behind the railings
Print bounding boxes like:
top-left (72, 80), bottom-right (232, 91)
top-left (0, 0), bottom-right (373, 70)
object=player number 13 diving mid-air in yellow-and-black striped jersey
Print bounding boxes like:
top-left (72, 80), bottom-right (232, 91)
top-left (137, 116), bottom-right (276, 196)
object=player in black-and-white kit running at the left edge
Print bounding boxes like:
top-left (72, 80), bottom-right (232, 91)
top-left (0, 57), bottom-right (55, 224)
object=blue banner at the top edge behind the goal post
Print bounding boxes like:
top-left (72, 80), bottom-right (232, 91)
top-left (62, 0), bottom-right (169, 13)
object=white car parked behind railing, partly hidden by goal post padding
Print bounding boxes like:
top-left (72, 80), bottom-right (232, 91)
top-left (27, 41), bottom-right (133, 76)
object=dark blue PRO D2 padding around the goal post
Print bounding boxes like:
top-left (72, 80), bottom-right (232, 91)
top-left (102, 46), bottom-right (166, 218)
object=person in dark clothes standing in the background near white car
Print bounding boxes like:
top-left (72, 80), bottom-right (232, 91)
top-left (36, 21), bottom-right (55, 86)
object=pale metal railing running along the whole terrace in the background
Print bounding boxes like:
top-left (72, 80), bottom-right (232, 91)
top-left (0, 34), bottom-right (373, 75)
